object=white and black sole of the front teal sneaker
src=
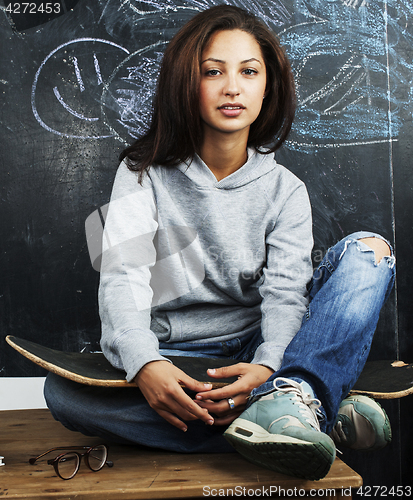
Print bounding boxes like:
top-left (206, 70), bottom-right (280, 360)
top-left (224, 418), bottom-right (335, 480)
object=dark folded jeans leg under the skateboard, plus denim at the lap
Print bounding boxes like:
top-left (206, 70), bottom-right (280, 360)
top-left (44, 329), bottom-right (263, 453)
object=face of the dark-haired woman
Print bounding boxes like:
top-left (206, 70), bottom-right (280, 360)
top-left (200, 30), bottom-right (267, 141)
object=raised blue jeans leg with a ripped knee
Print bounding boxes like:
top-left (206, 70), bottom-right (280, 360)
top-left (246, 231), bottom-right (395, 433)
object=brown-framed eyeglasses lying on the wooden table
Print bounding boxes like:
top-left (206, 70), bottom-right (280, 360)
top-left (29, 444), bottom-right (113, 479)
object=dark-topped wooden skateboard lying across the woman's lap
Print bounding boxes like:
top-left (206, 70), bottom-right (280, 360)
top-left (6, 335), bottom-right (413, 399)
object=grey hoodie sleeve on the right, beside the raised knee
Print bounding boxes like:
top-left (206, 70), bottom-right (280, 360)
top-left (252, 181), bottom-right (313, 371)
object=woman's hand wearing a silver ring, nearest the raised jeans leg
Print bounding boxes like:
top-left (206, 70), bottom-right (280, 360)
top-left (196, 363), bottom-right (274, 425)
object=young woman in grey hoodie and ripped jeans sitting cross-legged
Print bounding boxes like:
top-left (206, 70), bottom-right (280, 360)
top-left (45, 5), bottom-right (394, 479)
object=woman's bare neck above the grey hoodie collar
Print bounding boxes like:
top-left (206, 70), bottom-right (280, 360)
top-left (199, 129), bottom-right (248, 181)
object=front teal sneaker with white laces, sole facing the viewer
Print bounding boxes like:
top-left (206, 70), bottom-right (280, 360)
top-left (224, 378), bottom-right (336, 480)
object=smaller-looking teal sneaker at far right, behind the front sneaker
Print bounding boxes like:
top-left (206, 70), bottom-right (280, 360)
top-left (330, 395), bottom-right (391, 451)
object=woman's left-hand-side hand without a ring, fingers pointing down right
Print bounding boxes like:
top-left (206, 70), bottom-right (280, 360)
top-left (134, 361), bottom-right (214, 431)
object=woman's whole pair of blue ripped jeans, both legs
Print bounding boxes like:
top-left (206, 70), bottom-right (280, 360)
top-left (45, 232), bottom-right (395, 453)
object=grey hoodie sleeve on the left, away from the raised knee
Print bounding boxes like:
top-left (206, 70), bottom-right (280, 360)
top-left (99, 163), bottom-right (169, 381)
